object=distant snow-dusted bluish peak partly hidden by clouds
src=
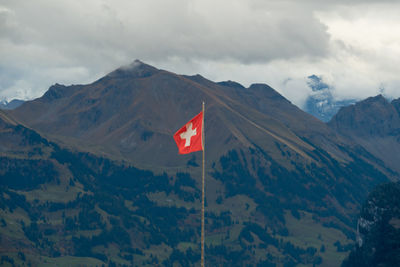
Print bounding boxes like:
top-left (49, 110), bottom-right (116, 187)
top-left (304, 75), bottom-right (356, 122)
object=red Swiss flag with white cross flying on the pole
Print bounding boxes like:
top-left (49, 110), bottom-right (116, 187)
top-left (174, 112), bottom-right (203, 154)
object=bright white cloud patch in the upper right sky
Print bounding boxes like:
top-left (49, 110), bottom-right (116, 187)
top-left (312, 4), bottom-right (400, 98)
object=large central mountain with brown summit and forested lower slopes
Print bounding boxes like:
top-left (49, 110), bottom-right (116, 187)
top-left (0, 61), bottom-right (398, 266)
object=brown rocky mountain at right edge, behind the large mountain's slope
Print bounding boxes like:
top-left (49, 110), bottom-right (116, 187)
top-left (328, 95), bottom-right (400, 175)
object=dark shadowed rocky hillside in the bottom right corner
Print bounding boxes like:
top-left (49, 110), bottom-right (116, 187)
top-left (342, 183), bottom-right (400, 267)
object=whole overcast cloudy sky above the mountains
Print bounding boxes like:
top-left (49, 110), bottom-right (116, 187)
top-left (0, 0), bottom-right (400, 106)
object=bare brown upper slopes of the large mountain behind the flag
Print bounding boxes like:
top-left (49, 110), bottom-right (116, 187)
top-left (10, 61), bottom-right (346, 170)
